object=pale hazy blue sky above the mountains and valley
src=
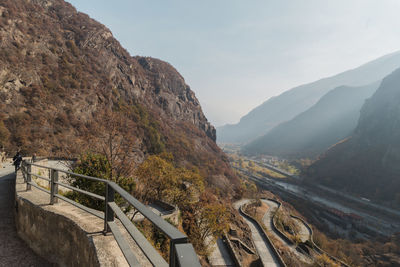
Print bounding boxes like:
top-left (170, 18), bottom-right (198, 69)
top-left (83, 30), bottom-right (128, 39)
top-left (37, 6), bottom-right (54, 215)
top-left (68, 0), bottom-right (400, 126)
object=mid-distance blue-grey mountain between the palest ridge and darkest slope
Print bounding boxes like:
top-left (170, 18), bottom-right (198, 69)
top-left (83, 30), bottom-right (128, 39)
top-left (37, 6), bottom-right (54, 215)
top-left (244, 81), bottom-right (380, 158)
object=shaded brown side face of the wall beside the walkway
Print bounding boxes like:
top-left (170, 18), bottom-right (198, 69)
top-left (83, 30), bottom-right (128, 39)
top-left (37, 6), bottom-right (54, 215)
top-left (15, 195), bottom-right (100, 266)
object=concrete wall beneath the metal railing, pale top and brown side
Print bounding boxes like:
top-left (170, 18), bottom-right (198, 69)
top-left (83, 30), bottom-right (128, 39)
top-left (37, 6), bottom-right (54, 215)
top-left (15, 172), bottom-right (138, 267)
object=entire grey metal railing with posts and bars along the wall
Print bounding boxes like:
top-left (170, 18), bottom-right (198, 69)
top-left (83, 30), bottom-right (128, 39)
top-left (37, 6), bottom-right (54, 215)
top-left (21, 161), bottom-right (200, 267)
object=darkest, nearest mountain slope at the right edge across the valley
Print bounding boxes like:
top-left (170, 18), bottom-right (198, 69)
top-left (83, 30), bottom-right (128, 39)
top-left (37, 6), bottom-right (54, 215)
top-left (307, 69), bottom-right (400, 207)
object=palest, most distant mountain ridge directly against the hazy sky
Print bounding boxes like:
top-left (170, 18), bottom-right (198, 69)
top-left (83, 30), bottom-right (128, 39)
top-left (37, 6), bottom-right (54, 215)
top-left (217, 52), bottom-right (400, 144)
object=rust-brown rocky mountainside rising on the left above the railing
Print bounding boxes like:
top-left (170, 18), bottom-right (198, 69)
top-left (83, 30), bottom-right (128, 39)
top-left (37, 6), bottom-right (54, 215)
top-left (0, 0), bottom-right (236, 193)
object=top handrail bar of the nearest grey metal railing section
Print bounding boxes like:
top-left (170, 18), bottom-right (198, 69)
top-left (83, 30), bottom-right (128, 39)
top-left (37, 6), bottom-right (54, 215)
top-left (108, 181), bottom-right (187, 243)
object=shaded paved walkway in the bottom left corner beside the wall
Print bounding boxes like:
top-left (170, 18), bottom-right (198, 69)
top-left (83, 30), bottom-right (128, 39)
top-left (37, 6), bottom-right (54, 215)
top-left (0, 164), bottom-right (53, 267)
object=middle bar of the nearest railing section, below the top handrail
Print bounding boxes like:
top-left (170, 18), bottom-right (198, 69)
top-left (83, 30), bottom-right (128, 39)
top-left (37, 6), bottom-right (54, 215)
top-left (108, 202), bottom-right (168, 266)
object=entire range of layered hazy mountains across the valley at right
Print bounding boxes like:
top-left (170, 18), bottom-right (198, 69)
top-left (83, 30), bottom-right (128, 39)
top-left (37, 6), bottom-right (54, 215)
top-left (217, 52), bottom-right (400, 207)
